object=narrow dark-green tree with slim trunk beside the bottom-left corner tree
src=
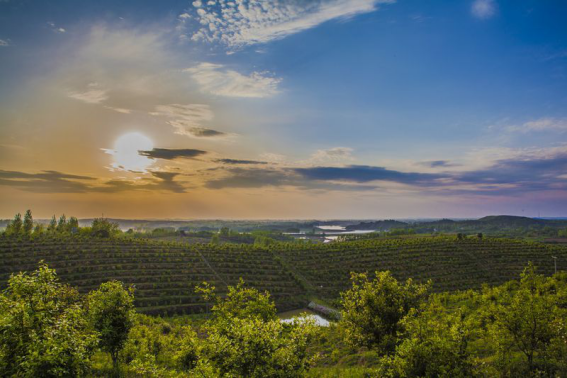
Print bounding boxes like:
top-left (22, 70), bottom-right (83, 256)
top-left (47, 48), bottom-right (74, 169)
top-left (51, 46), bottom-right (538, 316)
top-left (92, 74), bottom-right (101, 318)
top-left (87, 281), bottom-right (135, 370)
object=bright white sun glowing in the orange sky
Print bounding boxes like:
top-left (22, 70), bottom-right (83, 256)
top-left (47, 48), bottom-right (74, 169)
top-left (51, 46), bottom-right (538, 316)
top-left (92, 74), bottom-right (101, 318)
top-left (112, 132), bottom-right (154, 172)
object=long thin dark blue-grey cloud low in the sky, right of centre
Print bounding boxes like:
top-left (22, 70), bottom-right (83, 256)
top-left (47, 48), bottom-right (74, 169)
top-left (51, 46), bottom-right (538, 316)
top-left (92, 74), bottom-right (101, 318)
top-left (294, 165), bottom-right (445, 184)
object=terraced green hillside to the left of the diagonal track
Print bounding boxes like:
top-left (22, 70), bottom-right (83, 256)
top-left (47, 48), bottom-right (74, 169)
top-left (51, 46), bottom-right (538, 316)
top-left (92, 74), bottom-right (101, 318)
top-left (0, 237), bottom-right (305, 314)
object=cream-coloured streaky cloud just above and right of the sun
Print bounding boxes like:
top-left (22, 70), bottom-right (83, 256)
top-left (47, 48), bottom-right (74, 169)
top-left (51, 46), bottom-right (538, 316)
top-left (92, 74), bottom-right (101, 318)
top-left (150, 104), bottom-right (228, 138)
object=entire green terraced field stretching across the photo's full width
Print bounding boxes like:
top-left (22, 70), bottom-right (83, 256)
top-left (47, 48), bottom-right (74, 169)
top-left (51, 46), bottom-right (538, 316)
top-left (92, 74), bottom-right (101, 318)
top-left (0, 235), bottom-right (567, 314)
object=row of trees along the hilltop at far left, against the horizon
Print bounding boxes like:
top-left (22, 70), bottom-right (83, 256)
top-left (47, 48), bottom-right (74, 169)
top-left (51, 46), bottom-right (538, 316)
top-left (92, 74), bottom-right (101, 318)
top-left (4, 210), bottom-right (122, 238)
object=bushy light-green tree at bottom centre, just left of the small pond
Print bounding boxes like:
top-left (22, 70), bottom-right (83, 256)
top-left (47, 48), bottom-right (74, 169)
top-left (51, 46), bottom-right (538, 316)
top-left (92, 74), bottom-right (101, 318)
top-left (197, 280), bottom-right (314, 377)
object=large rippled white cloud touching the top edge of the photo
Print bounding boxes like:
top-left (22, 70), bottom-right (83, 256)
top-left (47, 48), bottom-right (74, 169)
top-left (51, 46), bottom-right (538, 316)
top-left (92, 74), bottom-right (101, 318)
top-left (186, 0), bottom-right (395, 48)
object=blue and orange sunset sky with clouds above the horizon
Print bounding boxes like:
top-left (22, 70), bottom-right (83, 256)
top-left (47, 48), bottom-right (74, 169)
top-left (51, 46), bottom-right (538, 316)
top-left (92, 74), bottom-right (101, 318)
top-left (0, 0), bottom-right (567, 219)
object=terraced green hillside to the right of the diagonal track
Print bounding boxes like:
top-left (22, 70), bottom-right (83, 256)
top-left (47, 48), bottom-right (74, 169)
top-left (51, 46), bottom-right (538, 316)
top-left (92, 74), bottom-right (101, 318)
top-left (279, 237), bottom-right (567, 299)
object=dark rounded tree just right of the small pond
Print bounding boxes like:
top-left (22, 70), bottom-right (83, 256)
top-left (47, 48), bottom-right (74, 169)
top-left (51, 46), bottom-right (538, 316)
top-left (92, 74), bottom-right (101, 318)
top-left (341, 271), bottom-right (430, 351)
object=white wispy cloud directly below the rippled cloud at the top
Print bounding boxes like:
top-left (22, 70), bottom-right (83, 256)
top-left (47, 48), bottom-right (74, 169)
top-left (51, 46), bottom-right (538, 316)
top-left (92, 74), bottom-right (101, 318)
top-left (184, 63), bottom-right (282, 98)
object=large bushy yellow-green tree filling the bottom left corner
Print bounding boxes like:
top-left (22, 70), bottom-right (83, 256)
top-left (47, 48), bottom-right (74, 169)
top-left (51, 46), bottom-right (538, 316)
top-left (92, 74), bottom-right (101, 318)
top-left (0, 263), bottom-right (97, 377)
